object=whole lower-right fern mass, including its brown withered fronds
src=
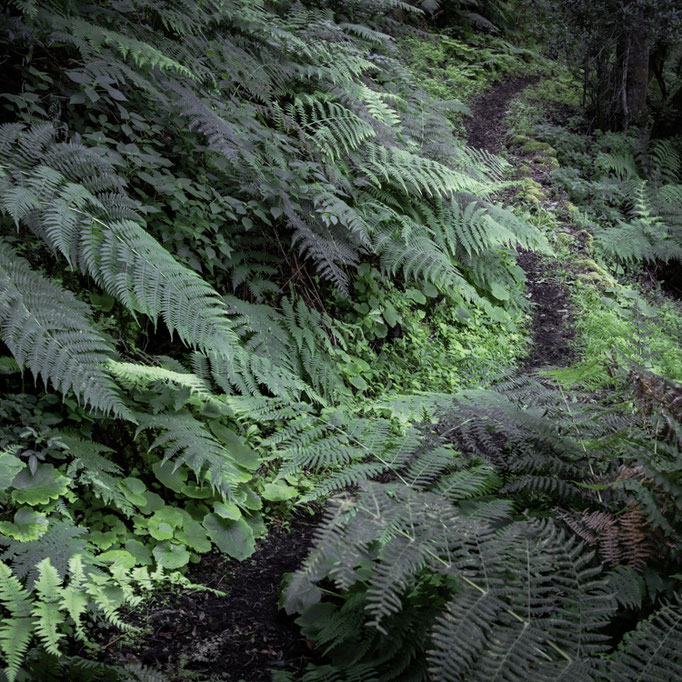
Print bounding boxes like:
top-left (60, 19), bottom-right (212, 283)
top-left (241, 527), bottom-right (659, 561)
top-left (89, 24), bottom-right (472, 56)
top-left (284, 362), bottom-right (679, 680)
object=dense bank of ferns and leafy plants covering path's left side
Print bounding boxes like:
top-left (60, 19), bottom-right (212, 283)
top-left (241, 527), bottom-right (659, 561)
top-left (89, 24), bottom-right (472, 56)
top-left (0, 0), bottom-right (548, 682)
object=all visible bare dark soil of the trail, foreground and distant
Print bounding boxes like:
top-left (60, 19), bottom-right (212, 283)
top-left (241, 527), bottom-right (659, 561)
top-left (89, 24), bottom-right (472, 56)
top-left (109, 77), bottom-right (574, 682)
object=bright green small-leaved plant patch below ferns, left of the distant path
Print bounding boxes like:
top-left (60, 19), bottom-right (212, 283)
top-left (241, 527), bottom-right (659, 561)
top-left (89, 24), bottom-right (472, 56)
top-left (329, 267), bottom-right (530, 396)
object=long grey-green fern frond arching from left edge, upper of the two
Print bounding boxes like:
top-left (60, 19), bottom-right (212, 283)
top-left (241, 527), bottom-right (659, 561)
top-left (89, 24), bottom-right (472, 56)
top-left (0, 125), bottom-right (236, 353)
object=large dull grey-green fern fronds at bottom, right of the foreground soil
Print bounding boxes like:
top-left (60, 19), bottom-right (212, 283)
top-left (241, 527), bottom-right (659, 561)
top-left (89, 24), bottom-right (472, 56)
top-left (287, 484), bottom-right (614, 680)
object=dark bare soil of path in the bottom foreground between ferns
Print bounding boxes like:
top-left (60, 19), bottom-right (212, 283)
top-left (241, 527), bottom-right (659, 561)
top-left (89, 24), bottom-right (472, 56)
top-left (108, 517), bottom-right (319, 682)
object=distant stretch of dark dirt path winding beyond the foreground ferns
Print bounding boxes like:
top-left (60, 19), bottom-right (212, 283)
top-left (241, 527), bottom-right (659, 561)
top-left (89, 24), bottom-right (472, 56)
top-left (467, 77), bottom-right (574, 371)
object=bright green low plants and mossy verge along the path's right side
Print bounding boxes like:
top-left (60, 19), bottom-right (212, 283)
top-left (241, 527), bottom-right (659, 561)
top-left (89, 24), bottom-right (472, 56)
top-left (507, 74), bottom-right (682, 386)
